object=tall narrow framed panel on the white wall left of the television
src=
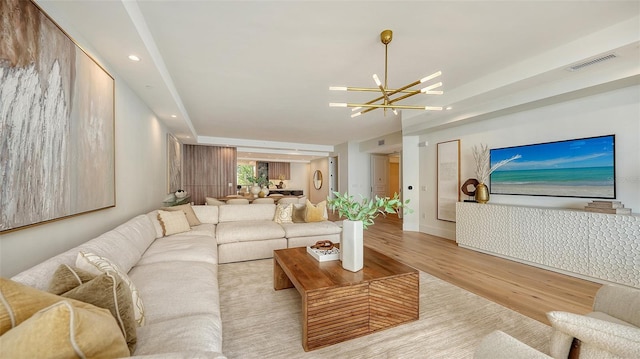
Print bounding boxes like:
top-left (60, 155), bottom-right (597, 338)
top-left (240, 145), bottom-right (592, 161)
top-left (437, 140), bottom-right (460, 222)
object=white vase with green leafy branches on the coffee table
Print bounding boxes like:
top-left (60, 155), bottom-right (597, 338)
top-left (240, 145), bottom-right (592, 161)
top-left (327, 192), bottom-right (413, 272)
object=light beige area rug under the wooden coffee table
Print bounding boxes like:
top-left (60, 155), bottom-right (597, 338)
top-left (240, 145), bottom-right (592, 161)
top-left (218, 259), bottom-right (551, 359)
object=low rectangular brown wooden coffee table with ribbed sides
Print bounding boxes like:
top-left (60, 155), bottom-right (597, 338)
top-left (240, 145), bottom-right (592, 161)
top-left (273, 247), bottom-right (420, 351)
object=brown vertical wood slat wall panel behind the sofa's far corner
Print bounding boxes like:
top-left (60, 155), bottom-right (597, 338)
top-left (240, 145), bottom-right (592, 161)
top-left (183, 145), bottom-right (237, 204)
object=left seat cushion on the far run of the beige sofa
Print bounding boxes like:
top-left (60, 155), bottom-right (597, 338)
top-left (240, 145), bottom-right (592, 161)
top-left (216, 221), bottom-right (284, 244)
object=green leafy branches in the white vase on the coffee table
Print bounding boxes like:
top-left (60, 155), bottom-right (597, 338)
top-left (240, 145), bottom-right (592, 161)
top-left (327, 192), bottom-right (413, 229)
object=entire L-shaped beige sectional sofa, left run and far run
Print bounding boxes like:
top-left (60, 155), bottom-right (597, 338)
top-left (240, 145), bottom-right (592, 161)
top-left (5, 204), bottom-right (340, 358)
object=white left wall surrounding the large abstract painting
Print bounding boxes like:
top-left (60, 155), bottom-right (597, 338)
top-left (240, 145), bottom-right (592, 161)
top-left (0, 16), bottom-right (167, 277)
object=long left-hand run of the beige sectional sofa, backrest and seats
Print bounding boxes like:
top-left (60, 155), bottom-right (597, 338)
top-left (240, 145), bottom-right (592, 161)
top-left (12, 209), bottom-right (224, 358)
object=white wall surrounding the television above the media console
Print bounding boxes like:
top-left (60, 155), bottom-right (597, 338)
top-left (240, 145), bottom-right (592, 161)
top-left (419, 86), bottom-right (640, 239)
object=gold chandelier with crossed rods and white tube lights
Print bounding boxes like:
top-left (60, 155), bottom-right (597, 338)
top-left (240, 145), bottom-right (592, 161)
top-left (329, 30), bottom-right (443, 117)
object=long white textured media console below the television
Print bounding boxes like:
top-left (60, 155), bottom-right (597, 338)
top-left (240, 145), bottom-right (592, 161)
top-left (456, 202), bottom-right (640, 288)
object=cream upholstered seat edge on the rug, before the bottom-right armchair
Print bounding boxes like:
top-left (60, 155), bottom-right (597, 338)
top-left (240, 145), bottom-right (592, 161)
top-left (473, 330), bottom-right (551, 359)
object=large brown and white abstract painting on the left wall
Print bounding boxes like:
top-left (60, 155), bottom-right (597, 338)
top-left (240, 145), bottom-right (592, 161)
top-left (0, 0), bottom-right (116, 232)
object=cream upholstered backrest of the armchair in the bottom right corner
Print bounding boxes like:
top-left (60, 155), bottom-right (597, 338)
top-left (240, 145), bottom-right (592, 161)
top-left (593, 284), bottom-right (640, 327)
